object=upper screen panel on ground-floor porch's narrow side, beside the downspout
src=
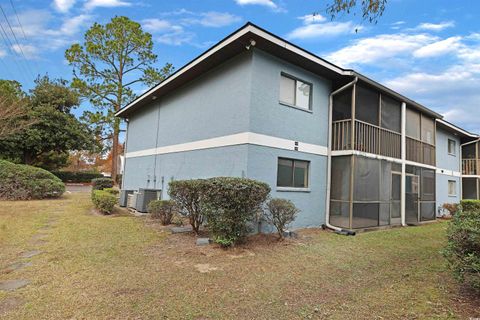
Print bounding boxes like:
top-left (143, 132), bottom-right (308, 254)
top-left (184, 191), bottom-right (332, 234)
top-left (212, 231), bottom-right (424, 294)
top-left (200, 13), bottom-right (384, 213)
top-left (330, 156), bottom-right (352, 201)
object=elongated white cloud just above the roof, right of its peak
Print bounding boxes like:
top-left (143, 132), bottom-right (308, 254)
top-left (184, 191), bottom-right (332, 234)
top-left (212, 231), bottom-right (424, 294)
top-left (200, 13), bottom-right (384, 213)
top-left (326, 33), bottom-right (437, 67)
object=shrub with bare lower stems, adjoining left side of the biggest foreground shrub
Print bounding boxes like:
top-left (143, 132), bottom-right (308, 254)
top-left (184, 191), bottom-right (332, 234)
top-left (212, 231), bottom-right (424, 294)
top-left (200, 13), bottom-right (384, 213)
top-left (168, 179), bottom-right (204, 234)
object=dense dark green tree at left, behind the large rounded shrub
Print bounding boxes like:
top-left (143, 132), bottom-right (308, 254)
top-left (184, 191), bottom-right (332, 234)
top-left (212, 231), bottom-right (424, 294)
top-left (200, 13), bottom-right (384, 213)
top-left (0, 76), bottom-right (95, 170)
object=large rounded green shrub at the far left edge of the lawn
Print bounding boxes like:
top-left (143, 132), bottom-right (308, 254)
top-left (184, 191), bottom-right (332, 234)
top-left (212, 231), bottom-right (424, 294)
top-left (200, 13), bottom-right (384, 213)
top-left (0, 160), bottom-right (65, 200)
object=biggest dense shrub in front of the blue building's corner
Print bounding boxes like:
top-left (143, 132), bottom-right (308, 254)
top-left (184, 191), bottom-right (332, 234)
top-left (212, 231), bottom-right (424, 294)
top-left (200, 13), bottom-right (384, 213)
top-left (202, 177), bottom-right (270, 247)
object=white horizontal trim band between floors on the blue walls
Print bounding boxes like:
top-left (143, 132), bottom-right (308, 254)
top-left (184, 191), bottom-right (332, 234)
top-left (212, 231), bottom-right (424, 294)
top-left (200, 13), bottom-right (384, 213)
top-left (125, 132), bottom-right (327, 158)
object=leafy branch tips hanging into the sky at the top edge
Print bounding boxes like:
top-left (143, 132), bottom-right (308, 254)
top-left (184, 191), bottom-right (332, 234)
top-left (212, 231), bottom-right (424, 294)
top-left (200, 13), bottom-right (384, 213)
top-left (327, 0), bottom-right (387, 23)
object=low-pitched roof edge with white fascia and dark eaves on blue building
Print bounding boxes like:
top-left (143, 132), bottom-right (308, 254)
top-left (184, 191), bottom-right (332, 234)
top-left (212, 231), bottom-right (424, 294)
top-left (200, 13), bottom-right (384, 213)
top-left (115, 22), bottom-right (442, 119)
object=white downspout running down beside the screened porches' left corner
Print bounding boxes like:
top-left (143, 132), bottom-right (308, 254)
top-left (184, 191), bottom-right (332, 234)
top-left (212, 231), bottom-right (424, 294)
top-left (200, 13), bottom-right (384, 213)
top-left (325, 77), bottom-right (358, 235)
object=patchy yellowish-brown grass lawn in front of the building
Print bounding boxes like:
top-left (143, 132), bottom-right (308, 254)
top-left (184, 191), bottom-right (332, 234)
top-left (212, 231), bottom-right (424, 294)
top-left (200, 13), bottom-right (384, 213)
top-left (0, 193), bottom-right (480, 319)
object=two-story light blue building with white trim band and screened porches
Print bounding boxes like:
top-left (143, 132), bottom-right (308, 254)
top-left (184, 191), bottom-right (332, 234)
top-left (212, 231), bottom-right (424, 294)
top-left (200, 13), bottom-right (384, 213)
top-left (116, 23), bottom-right (480, 229)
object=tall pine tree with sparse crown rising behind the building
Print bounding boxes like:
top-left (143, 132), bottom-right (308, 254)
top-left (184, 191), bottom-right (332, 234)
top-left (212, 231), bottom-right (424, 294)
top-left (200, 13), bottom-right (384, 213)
top-left (65, 17), bottom-right (173, 184)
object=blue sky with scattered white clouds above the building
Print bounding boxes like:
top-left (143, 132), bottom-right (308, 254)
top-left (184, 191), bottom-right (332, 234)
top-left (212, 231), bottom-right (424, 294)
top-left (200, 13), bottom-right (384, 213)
top-left (0, 0), bottom-right (480, 133)
